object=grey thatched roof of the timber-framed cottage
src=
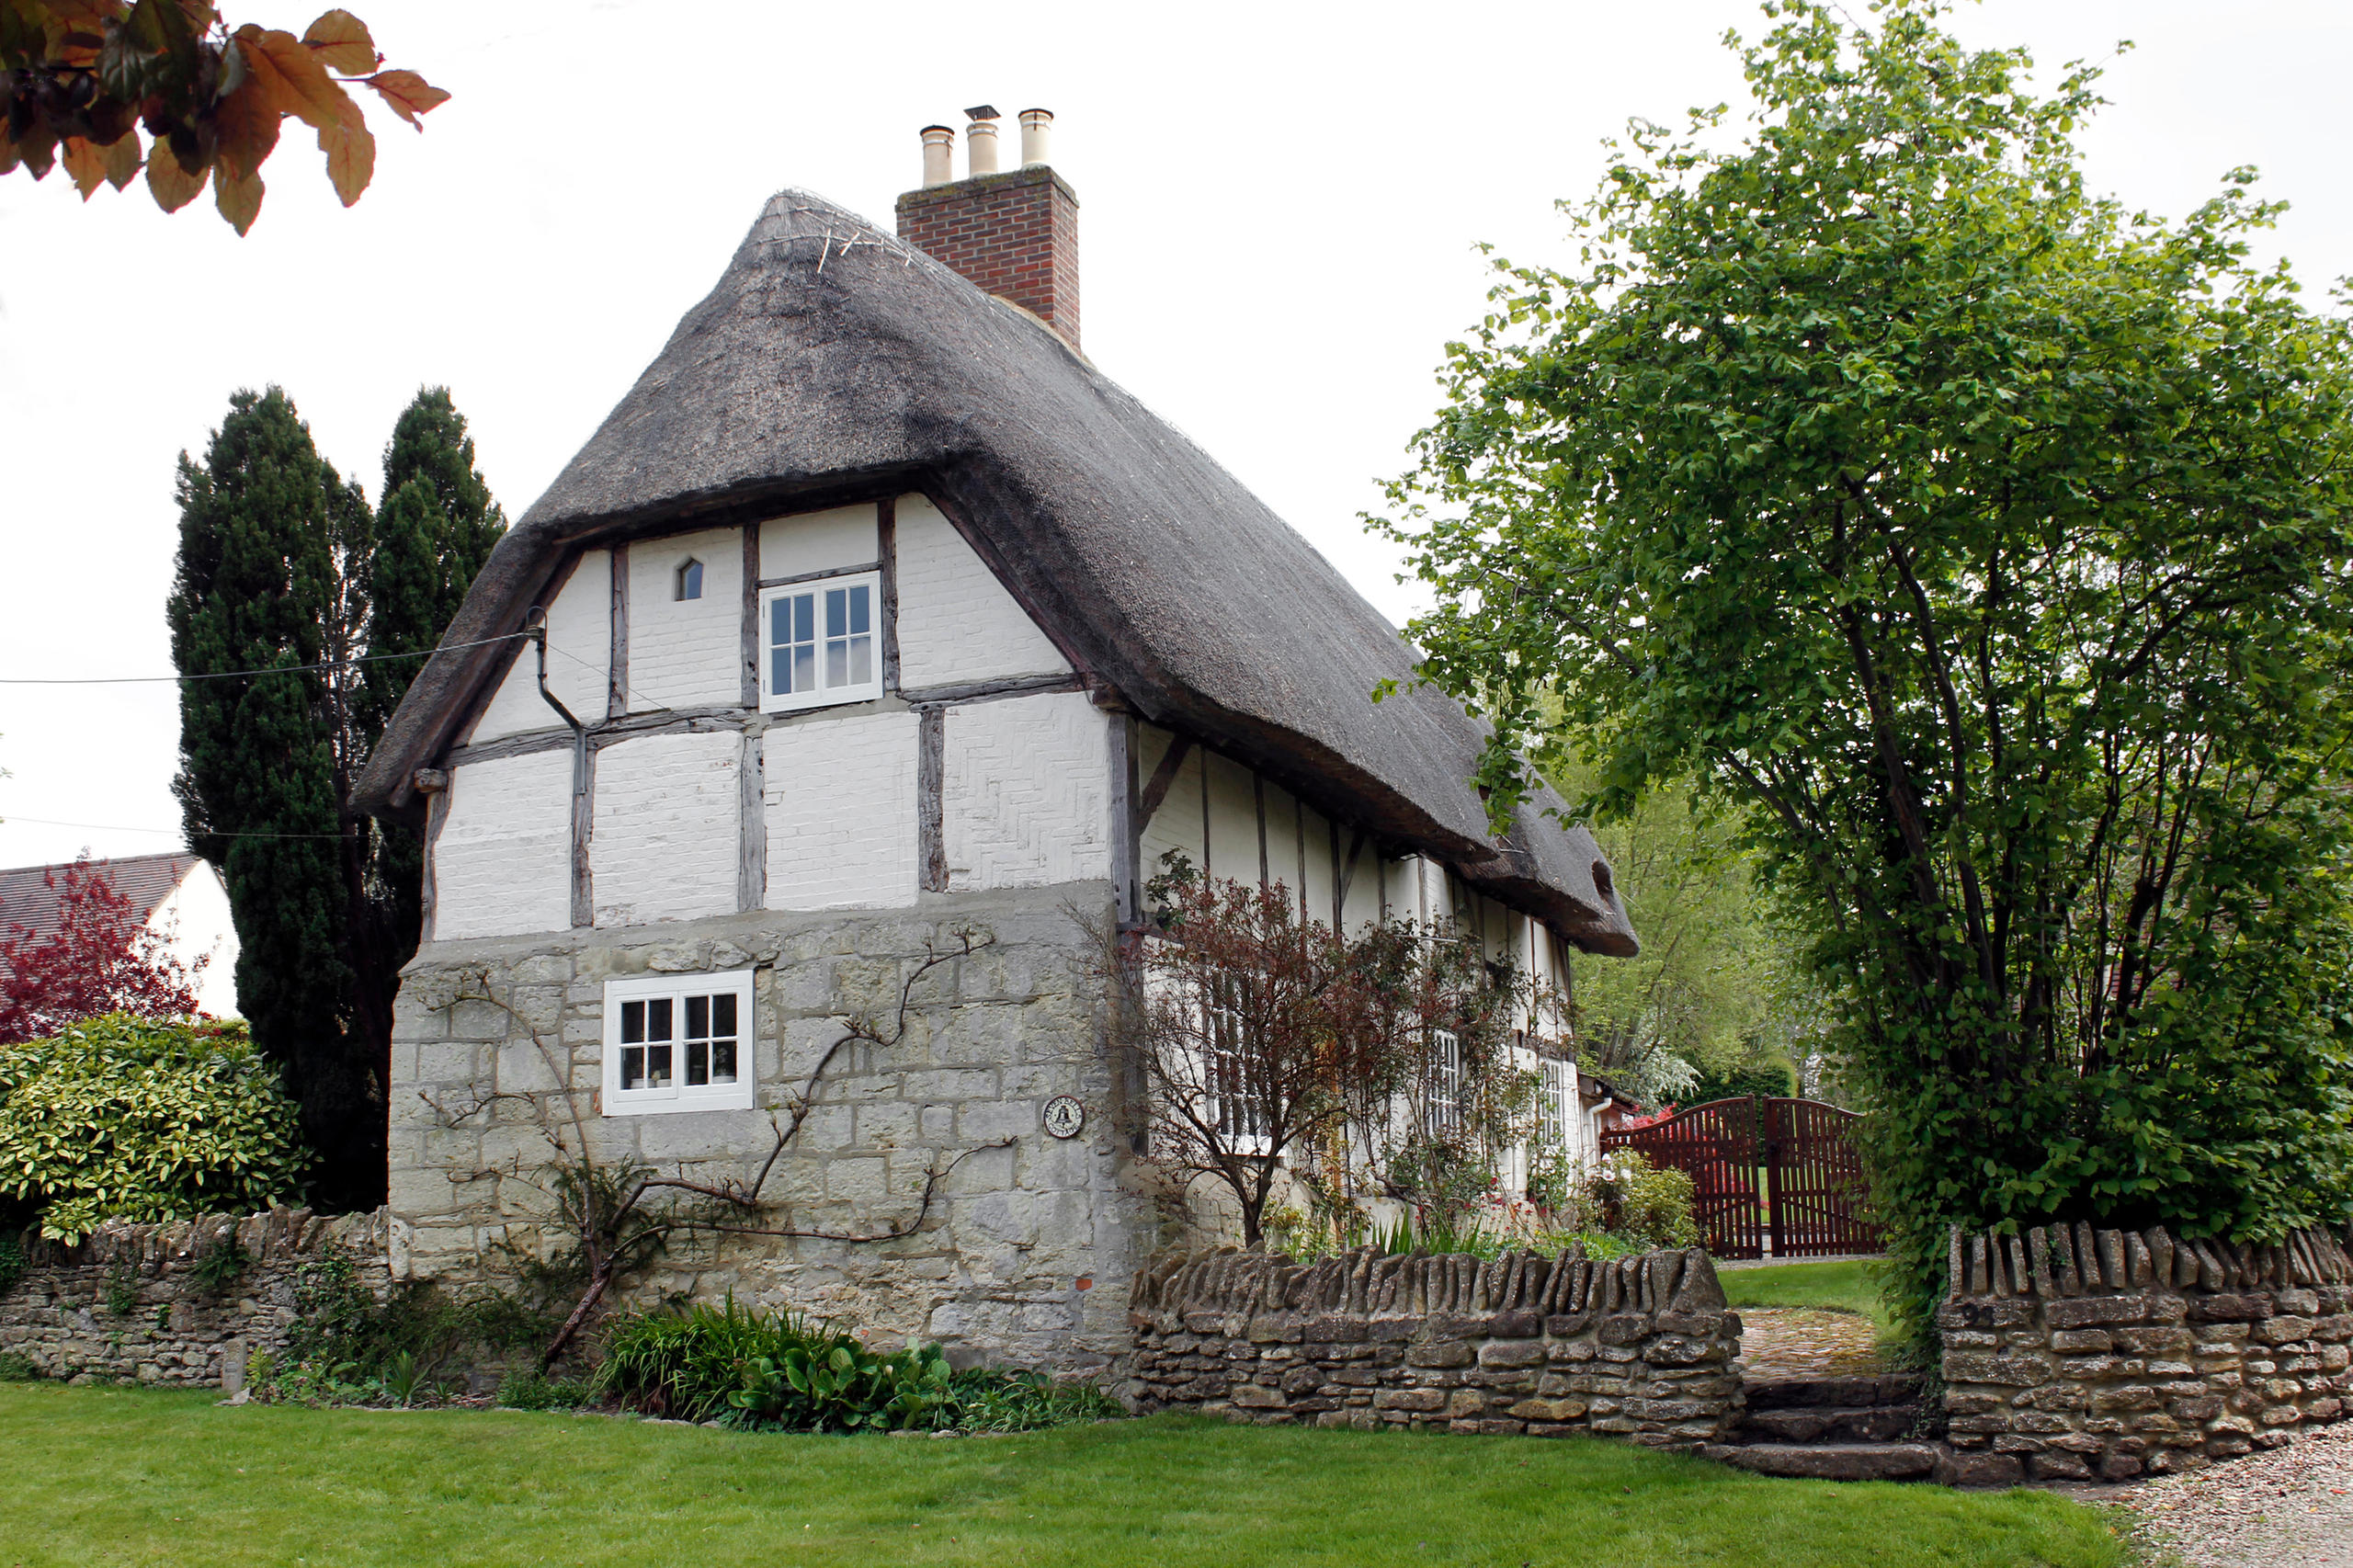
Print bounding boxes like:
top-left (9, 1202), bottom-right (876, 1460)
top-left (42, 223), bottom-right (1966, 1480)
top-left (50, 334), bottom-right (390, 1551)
top-left (358, 190), bottom-right (1638, 953)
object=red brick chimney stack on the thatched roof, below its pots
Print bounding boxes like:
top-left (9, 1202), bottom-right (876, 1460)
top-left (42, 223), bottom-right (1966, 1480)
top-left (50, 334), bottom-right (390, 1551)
top-left (899, 167), bottom-right (1077, 348)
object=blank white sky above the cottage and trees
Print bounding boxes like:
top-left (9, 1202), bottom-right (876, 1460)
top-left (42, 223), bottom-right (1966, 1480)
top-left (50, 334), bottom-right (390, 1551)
top-left (0, 0), bottom-right (2353, 867)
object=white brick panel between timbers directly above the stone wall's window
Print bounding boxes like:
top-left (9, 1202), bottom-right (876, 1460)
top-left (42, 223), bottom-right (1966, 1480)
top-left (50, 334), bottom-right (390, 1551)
top-left (588, 724), bottom-right (744, 926)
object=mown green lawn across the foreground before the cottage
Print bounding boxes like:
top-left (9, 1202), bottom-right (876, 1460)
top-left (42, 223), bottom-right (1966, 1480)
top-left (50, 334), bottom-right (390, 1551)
top-left (0, 1384), bottom-right (2131, 1568)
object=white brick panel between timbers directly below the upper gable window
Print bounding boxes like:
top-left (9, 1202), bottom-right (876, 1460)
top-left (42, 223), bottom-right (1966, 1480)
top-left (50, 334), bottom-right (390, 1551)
top-left (762, 713), bottom-right (917, 909)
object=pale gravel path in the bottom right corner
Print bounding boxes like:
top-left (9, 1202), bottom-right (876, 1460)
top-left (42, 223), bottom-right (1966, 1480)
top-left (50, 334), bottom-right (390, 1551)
top-left (2104, 1422), bottom-right (2353, 1568)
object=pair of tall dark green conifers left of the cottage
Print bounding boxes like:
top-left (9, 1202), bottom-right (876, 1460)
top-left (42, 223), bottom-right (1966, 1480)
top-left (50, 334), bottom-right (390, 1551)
top-left (172, 389), bottom-right (506, 1208)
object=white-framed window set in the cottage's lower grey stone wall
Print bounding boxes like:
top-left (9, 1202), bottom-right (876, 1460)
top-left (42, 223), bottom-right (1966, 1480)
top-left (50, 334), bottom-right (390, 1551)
top-left (605, 970), bottom-right (753, 1116)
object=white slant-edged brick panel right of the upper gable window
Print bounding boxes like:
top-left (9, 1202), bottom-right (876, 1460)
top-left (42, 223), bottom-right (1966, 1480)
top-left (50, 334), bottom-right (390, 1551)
top-left (899, 494), bottom-right (1071, 687)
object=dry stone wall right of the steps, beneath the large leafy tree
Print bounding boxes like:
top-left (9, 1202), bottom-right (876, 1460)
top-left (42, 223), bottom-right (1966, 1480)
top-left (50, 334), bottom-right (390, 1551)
top-left (1937, 1224), bottom-right (2353, 1481)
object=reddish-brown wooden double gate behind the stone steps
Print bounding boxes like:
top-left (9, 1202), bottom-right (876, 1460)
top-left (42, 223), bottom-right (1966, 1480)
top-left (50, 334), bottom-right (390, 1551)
top-left (1602, 1097), bottom-right (1880, 1257)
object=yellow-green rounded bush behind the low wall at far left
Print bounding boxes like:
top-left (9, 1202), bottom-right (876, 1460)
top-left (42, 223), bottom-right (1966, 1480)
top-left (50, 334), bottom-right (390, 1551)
top-left (0, 1012), bottom-right (308, 1241)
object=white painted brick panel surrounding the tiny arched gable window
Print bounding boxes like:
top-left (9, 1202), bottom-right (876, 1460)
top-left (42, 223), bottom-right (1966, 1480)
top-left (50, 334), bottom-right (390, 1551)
top-left (631, 528), bottom-right (744, 710)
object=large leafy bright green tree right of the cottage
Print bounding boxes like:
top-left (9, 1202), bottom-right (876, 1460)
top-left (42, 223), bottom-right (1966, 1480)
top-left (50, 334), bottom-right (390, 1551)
top-left (1391, 0), bottom-right (2353, 1345)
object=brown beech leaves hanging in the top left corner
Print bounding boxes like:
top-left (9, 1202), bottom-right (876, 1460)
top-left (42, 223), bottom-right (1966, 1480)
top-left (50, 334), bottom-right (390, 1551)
top-left (0, 0), bottom-right (449, 233)
